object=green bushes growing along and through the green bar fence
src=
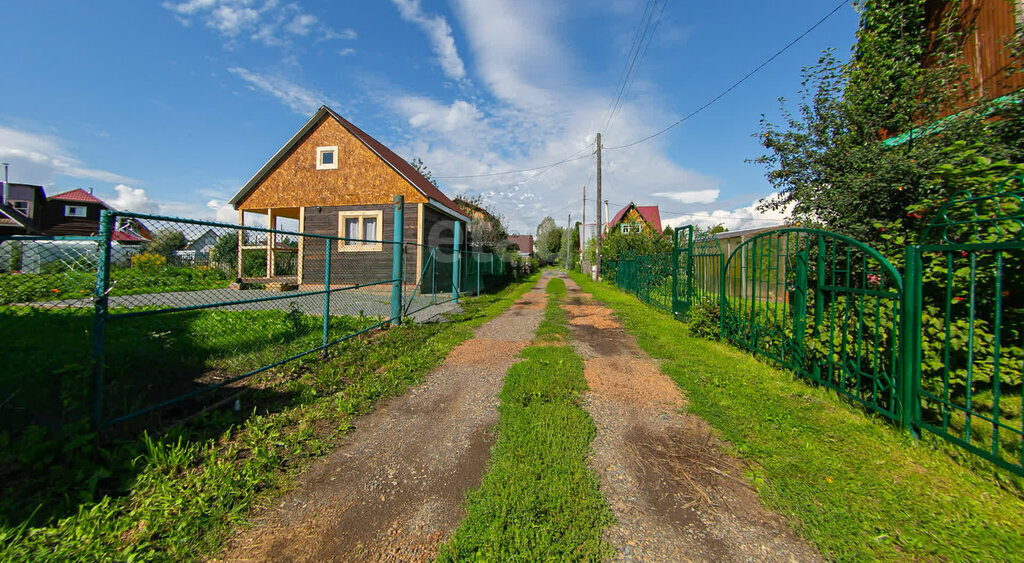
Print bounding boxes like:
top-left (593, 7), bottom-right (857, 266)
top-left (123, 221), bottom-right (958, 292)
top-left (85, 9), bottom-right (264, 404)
top-left (605, 177), bottom-right (1024, 476)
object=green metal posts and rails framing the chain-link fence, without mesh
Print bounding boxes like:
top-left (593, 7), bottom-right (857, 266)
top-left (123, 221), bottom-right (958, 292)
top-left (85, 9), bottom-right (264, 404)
top-left (0, 196), bottom-right (514, 429)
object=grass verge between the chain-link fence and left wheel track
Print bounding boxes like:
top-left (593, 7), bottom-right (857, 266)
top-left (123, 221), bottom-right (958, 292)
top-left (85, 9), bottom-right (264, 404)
top-left (0, 274), bottom-right (532, 561)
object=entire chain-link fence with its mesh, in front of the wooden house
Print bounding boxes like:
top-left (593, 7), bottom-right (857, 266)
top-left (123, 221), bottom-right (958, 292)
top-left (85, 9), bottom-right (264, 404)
top-left (0, 198), bottom-right (513, 430)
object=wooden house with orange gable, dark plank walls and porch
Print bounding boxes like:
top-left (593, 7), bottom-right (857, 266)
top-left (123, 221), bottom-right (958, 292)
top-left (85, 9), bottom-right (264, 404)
top-left (230, 106), bottom-right (468, 286)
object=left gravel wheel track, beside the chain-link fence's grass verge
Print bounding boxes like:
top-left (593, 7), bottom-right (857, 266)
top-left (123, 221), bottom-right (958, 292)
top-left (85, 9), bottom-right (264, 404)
top-left (221, 276), bottom-right (549, 561)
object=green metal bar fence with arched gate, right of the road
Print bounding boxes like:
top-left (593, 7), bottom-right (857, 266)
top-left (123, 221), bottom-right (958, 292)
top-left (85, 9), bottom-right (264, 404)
top-left (605, 205), bottom-right (1024, 476)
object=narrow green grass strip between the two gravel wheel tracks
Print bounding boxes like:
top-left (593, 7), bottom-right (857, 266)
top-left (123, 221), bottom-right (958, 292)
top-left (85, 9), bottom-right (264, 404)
top-left (438, 278), bottom-right (612, 561)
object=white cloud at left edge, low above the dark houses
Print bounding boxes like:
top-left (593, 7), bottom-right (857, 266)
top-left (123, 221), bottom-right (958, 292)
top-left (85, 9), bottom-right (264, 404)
top-left (0, 127), bottom-right (136, 185)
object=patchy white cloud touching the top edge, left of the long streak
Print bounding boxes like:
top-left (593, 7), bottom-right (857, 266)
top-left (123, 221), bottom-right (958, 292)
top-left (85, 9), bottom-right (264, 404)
top-left (163, 0), bottom-right (356, 47)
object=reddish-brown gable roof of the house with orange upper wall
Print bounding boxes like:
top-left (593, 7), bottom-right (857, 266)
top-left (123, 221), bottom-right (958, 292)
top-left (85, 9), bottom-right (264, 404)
top-left (228, 105), bottom-right (465, 219)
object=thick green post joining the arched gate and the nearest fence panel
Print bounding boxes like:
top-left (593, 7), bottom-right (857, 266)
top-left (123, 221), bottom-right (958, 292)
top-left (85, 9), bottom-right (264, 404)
top-left (896, 246), bottom-right (923, 431)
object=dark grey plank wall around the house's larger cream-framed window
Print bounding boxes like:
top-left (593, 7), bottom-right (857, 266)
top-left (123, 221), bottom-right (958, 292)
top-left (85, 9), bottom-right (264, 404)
top-left (299, 203), bottom-right (419, 286)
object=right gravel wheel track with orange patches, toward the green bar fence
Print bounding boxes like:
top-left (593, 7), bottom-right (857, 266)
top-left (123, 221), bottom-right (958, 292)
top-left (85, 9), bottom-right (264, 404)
top-left (563, 278), bottom-right (821, 561)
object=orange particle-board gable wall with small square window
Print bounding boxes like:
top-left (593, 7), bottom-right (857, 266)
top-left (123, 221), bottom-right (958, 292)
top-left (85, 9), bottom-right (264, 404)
top-left (238, 116), bottom-right (427, 211)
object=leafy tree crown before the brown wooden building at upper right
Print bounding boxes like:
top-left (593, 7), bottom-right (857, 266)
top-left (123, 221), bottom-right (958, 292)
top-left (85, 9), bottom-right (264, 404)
top-left (757, 0), bottom-right (1024, 244)
